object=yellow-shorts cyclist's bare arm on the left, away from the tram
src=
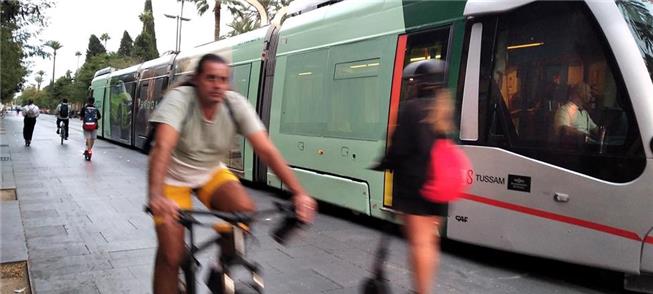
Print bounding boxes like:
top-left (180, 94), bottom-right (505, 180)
top-left (148, 123), bottom-right (179, 219)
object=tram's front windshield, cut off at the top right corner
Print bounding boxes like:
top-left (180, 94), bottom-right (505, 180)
top-left (617, 0), bottom-right (653, 80)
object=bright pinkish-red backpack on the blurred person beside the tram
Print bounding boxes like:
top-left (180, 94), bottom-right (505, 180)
top-left (420, 139), bottom-right (472, 203)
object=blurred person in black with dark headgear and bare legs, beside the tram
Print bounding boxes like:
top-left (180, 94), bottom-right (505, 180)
top-left (376, 60), bottom-right (454, 294)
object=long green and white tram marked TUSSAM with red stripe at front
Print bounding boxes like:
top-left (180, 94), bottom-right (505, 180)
top-left (91, 0), bottom-right (653, 291)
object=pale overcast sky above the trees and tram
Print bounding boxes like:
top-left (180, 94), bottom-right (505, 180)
top-left (26, 0), bottom-right (231, 85)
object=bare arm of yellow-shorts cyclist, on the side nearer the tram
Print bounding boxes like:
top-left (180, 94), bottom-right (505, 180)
top-left (247, 130), bottom-right (317, 222)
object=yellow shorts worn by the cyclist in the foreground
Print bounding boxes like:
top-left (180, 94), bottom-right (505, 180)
top-left (154, 168), bottom-right (239, 224)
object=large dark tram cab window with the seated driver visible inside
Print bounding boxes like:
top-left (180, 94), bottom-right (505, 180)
top-left (486, 2), bottom-right (645, 182)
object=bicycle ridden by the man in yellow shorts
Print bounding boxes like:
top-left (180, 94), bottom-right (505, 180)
top-left (145, 202), bottom-right (303, 294)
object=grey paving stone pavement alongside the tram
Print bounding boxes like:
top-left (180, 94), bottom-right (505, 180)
top-left (0, 115), bottom-right (624, 294)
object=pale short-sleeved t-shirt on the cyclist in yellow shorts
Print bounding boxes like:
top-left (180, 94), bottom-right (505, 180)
top-left (150, 86), bottom-right (265, 187)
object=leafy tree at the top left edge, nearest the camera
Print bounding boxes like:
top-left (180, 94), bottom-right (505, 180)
top-left (0, 0), bottom-right (53, 103)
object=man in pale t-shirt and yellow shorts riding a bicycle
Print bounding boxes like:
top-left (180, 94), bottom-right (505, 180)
top-left (148, 54), bottom-right (316, 293)
